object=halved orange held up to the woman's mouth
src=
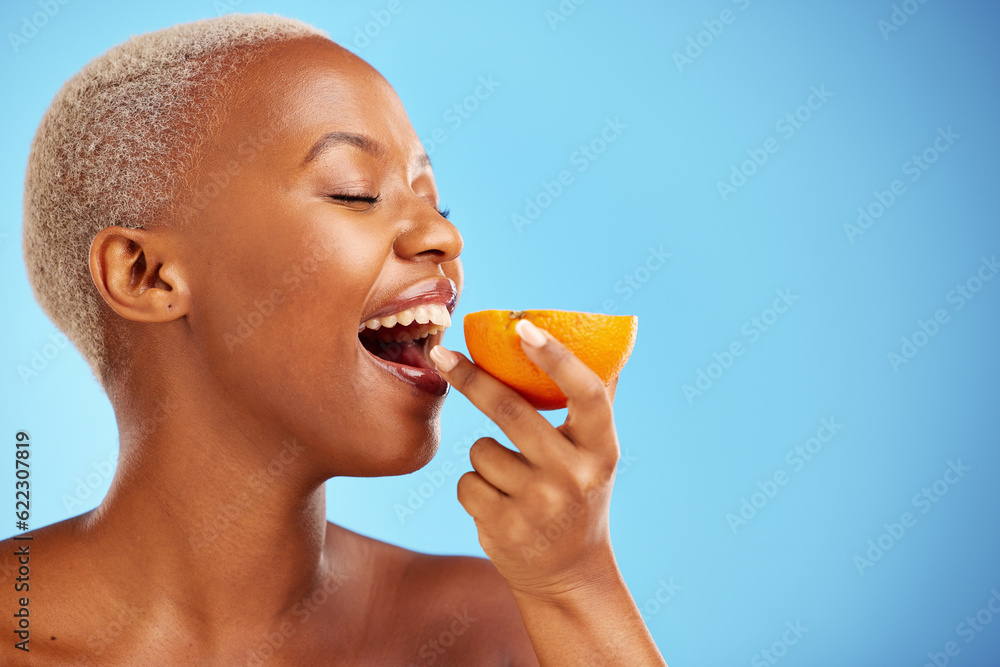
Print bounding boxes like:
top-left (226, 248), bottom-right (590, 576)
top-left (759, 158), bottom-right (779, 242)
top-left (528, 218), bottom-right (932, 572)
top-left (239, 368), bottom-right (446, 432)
top-left (463, 310), bottom-right (639, 410)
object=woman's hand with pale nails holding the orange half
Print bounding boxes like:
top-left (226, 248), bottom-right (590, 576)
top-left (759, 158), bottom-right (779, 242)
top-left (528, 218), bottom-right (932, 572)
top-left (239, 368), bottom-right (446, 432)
top-left (431, 320), bottom-right (620, 601)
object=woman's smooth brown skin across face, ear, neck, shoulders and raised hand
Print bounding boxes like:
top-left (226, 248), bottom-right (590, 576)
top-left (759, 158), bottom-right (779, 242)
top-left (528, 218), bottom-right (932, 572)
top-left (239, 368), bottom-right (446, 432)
top-left (0, 38), bottom-right (663, 666)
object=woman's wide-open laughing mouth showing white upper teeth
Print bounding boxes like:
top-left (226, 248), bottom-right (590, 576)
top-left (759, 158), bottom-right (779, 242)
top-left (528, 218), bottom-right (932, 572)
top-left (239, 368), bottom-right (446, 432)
top-left (358, 303), bottom-right (451, 395)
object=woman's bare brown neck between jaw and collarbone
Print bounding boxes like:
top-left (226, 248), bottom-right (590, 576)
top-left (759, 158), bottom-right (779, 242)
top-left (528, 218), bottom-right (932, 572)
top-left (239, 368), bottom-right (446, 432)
top-left (86, 370), bottom-right (329, 634)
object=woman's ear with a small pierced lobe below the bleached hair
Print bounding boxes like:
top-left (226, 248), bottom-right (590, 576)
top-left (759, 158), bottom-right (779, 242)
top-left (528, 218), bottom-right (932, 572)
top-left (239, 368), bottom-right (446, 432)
top-left (90, 227), bottom-right (190, 322)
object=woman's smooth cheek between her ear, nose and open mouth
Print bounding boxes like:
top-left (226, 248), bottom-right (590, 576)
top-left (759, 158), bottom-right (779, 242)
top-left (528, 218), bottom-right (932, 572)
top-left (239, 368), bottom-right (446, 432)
top-left (191, 201), bottom-right (385, 402)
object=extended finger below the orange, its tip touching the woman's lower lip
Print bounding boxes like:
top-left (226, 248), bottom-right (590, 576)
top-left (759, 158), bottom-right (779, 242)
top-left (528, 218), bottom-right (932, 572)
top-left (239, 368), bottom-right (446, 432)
top-left (431, 345), bottom-right (563, 461)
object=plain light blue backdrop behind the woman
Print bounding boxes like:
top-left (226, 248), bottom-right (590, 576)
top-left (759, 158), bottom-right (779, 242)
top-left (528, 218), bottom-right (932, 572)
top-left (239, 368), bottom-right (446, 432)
top-left (0, 0), bottom-right (1000, 667)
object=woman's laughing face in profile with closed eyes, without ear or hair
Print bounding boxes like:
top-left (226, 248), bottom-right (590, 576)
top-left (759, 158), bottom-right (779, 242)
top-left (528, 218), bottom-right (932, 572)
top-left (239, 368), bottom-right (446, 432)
top-left (177, 38), bottom-right (462, 475)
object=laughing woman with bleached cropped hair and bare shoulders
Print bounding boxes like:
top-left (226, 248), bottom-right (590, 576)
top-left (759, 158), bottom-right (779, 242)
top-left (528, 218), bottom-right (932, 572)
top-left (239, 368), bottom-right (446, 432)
top-left (7, 15), bottom-right (663, 665)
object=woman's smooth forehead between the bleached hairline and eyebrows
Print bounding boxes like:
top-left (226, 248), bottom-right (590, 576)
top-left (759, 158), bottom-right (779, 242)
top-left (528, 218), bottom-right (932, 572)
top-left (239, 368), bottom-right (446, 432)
top-left (218, 37), bottom-right (423, 168)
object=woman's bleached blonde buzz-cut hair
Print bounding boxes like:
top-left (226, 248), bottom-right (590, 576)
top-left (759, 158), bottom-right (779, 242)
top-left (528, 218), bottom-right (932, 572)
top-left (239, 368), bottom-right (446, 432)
top-left (23, 14), bottom-right (329, 387)
